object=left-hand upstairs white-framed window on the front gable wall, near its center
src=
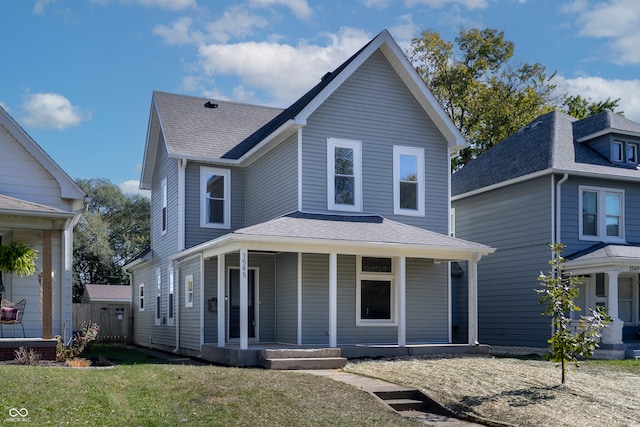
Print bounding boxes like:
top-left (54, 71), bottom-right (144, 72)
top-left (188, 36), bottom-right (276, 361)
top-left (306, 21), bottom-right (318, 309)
top-left (327, 138), bottom-right (362, 212)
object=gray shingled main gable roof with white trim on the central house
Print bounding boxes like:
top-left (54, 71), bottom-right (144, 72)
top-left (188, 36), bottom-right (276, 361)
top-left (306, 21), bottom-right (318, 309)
top-left (141, 30), bottom-right (466, 188)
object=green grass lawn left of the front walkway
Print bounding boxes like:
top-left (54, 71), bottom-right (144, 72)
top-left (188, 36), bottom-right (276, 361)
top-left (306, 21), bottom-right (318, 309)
top-left (0, 345), bottom-right (416, 426)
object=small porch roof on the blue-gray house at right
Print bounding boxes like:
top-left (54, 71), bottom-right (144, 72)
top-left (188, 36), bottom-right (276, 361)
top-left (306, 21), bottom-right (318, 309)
top-left (565, 243), bottom-right (640, 274)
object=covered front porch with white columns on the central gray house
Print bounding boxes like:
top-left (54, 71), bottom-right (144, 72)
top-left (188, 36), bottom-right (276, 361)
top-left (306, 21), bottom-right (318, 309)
top-left (175, 212), bottom-right (493, 366)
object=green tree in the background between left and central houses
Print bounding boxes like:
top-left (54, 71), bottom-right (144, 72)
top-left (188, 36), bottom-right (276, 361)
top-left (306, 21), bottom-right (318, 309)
top-left (73, 179), bottom-right (151, 301)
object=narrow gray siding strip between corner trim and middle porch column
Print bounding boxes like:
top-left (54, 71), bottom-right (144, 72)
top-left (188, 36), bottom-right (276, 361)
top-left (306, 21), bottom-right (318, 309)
top-left (302, 254), bottom-right (329, 345)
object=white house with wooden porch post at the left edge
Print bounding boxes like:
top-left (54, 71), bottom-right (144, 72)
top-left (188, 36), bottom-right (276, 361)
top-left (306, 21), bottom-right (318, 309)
top-left (0, 107), bottom-right (85, 342)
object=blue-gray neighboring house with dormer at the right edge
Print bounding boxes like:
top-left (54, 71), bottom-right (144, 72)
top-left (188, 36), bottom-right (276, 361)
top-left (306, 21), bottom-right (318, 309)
top-left (451, 112), bottom-right (640, 357)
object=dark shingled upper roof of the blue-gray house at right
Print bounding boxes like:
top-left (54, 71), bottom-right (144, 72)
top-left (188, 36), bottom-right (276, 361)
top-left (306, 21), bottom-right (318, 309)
top-left (451, 111), bottom-right (640, 199)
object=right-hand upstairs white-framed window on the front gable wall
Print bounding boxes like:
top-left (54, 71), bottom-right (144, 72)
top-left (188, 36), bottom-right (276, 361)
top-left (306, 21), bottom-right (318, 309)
top-left (393, 145), bottom-right (424, 216)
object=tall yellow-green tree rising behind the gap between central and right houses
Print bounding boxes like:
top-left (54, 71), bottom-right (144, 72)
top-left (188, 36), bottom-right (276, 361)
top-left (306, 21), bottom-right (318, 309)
top-left (409, 28), bottom-right (556, 170)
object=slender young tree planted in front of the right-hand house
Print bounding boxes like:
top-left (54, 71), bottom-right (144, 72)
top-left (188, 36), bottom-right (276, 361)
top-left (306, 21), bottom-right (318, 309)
top-left (536, 243), bottom-right (611, 385)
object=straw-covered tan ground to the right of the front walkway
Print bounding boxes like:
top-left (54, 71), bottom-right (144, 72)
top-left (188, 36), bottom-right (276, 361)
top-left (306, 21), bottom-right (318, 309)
top-left (346, 358), bottom-right (640, 427)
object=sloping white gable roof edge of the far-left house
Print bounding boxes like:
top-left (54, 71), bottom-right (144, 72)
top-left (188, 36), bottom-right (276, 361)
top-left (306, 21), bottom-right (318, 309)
top-left (0, 106), bottom-right (86, 202)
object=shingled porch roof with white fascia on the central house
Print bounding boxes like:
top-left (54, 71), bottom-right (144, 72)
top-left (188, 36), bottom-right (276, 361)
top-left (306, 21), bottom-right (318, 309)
top-left (171, 212), bottom-right (495, 261)
